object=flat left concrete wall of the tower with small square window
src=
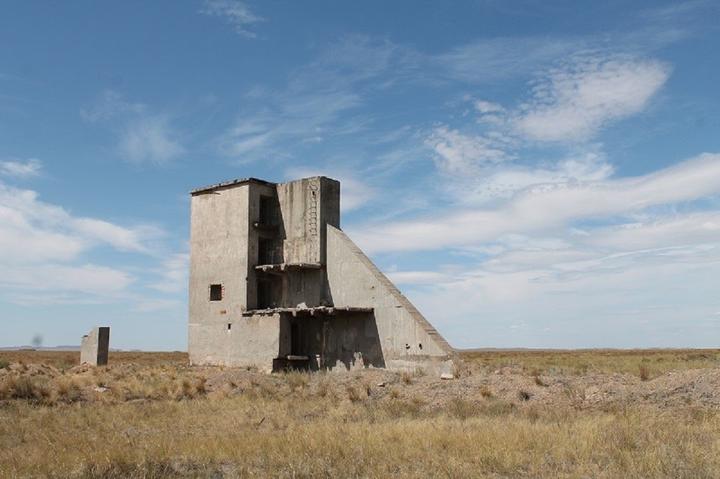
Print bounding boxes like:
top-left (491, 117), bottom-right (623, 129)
top-left (188, 184), bottom-right (250, 364)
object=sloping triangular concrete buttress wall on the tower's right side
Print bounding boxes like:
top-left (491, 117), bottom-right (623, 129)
top-left (327, 226), bottom-right (454, 376)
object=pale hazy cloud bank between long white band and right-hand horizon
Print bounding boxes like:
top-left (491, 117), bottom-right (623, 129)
top-left (390, 211), bottom-right (720, 347)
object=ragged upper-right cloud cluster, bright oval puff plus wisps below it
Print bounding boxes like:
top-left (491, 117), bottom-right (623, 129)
top-left (425, 53), bottom-right (670, 210)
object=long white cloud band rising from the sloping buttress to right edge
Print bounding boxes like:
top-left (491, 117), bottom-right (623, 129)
top-left (354, 154), bottom-right (720, 252)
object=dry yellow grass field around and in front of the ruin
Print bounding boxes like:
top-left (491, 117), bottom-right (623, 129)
top-left (0, 350), bottom-right (720, 478)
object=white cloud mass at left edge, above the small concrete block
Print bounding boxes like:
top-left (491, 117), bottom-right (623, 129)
top-left (0, 182), bottom-right (169, 304)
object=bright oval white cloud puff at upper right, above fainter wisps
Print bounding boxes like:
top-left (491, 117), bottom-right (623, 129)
top-left (514, 57), bottom-right (670, 141)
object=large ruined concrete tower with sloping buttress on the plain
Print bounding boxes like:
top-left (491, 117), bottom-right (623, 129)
top-left (188, 177), bottom-right (453, 374)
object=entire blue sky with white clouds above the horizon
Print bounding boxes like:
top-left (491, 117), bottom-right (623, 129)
top-left (0, 0), bottom-right (720, 350)
